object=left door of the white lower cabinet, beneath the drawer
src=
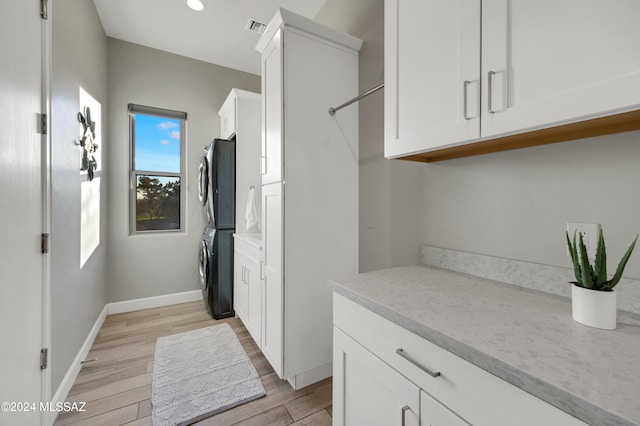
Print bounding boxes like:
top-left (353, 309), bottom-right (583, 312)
top-left (333, 327), bottom-right (420, 426)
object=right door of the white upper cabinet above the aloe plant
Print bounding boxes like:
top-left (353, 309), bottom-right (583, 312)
top-left (482, 0), bottom-right (640, 137)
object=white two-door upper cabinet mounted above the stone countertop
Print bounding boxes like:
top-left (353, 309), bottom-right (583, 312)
top-left (385, 0), bottom-right (640, 157)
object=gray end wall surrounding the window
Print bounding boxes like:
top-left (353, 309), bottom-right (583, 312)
top-left (107, 38), bottom-right (260, 302)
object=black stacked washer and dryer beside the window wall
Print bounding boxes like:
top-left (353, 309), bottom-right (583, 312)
top-left (198, 139), bottom-right (236, 319)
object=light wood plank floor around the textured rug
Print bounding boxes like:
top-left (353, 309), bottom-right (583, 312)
top-left (55, 302), bottom-right (332, 426)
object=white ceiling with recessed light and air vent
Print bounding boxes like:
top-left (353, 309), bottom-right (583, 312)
top-left (94, 0), bottom-right (326, 74)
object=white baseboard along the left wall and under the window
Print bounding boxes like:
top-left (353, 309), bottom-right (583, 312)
top-left (47, 290), bottom-right (202, 425)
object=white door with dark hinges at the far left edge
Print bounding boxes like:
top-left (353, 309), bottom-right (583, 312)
top-left (0, 0), bottom-right (50, 426)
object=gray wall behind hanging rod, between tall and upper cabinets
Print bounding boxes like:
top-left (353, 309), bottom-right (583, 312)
top-left (315, 0), bottom-right (423, 272)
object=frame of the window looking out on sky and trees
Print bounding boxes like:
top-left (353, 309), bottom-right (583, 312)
top-left (127, 103), bottom-right (187, 236)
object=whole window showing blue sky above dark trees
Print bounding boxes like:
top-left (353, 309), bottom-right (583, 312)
top-left (129, 104), bottom-right (187, 234)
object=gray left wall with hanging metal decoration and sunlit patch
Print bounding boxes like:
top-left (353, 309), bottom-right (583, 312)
top-left (50, 0), bottom-right (107, 392)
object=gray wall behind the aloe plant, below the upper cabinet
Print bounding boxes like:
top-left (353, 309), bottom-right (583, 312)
top-left (423, 132), bottom-right (640, 278)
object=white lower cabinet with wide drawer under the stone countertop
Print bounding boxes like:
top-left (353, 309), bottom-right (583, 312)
top-left (333, 293), bottom-right (586, 426)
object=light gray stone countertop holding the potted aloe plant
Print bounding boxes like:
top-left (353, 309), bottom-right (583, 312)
top-left (329, 266), bottom-right (640, 426)
